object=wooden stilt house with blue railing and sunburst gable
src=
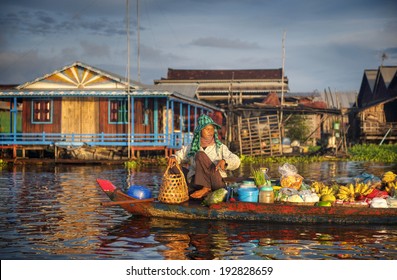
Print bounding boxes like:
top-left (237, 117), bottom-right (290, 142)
top-left (0, 62), bottom-right (220, 160)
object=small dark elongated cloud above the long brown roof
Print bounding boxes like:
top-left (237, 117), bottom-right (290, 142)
top-left (190, 37), bottom-right (260, 49)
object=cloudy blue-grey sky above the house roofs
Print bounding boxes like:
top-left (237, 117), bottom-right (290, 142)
top-left (0, 0), bottom-right (397, 92)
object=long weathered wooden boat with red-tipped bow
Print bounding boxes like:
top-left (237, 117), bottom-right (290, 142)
top-left (97, 179), bottom-right (397, 225)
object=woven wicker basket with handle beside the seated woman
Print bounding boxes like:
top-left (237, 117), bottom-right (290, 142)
top-left (158, 165), bottom-right (189, 204)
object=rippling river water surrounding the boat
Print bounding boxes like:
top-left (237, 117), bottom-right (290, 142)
top-left (0, 162), bottom-right (397, 260)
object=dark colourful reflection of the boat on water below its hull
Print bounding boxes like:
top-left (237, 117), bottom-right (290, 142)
top-left (97, 217), bottom-right (397, 260)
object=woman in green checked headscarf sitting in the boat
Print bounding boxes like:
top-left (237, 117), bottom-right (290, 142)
top-left (168, 115), bottom-right (240, 199)
